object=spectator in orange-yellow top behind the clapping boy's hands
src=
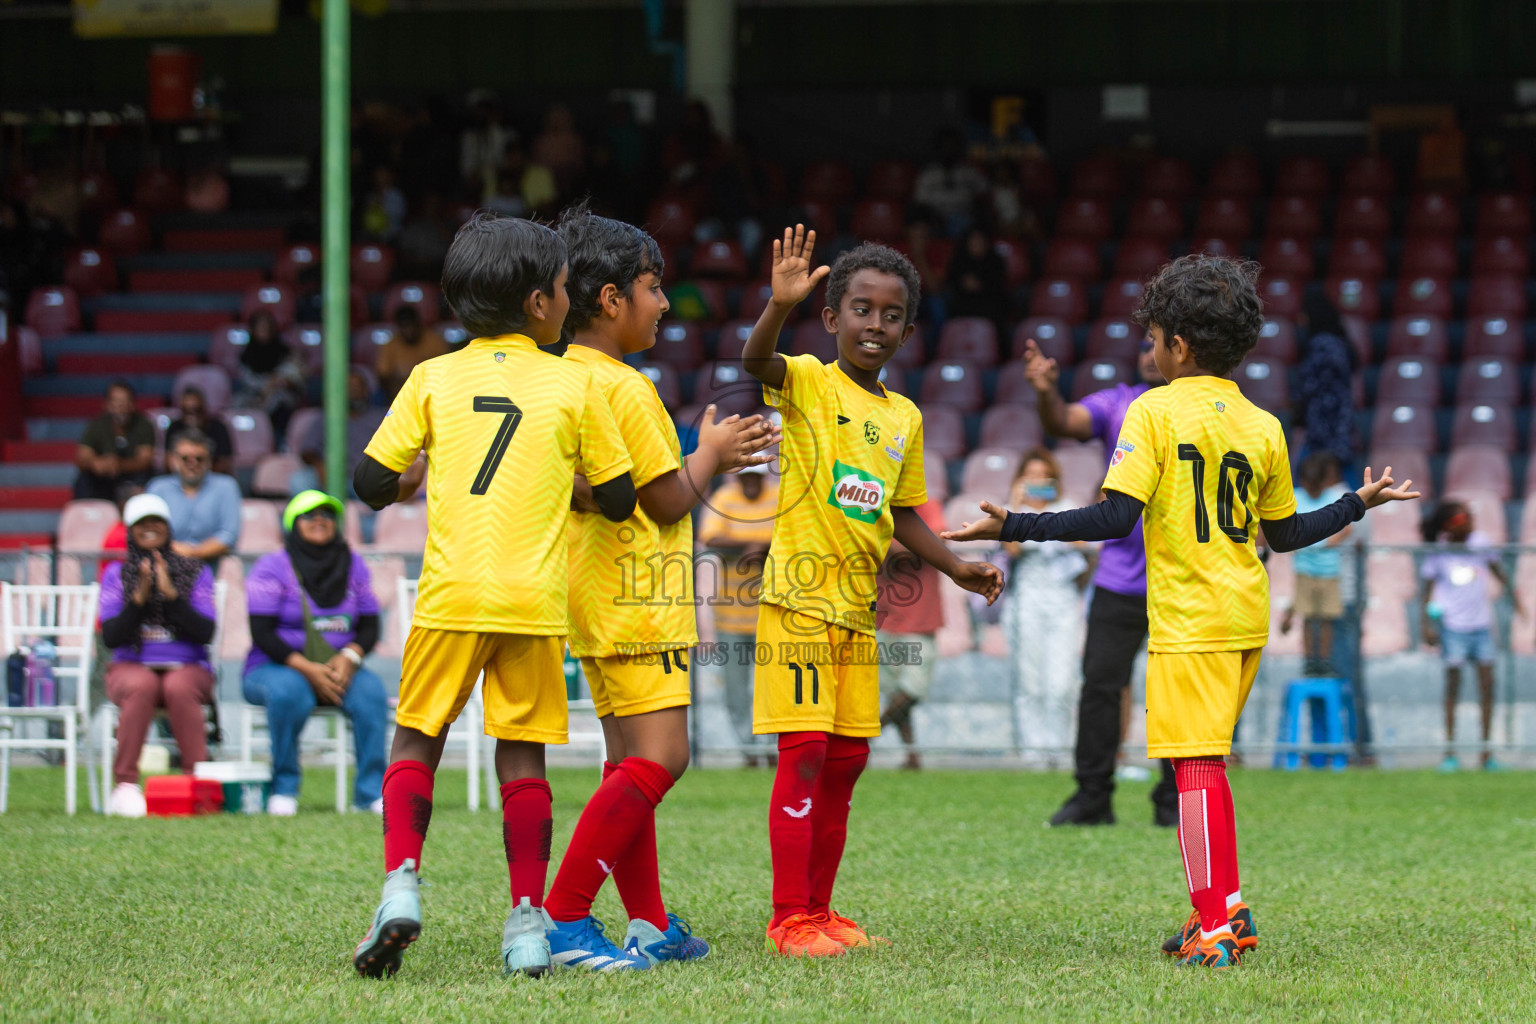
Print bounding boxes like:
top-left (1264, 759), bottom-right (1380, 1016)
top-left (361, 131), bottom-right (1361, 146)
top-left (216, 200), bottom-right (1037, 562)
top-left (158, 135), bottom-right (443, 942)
top-left (699, 465), bottom-right (779, 768)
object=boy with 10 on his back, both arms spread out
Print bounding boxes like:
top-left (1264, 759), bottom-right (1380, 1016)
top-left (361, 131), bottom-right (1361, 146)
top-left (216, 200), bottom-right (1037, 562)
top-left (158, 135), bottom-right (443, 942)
top-left (943, 256), bottom-right (1418, 967)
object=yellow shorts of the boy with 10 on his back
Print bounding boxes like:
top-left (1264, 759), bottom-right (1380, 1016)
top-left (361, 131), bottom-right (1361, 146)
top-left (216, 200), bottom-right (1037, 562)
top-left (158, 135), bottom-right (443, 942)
top-left (1147, 648), bottom-right (1261, 757)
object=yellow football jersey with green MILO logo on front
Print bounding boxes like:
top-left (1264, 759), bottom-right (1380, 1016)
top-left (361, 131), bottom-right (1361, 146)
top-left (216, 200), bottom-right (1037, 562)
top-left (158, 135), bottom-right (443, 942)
top-left (762, 356), bottom-right (928, 634)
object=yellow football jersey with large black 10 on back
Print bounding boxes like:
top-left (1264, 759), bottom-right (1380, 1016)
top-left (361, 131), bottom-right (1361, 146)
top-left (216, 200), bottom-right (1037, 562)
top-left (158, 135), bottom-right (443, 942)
top-left (1104, 376), bottom-right (1296, 654)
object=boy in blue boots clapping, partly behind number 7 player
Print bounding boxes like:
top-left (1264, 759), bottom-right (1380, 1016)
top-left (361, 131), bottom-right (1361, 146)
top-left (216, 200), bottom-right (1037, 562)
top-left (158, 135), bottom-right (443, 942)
top-left (544, 204), bottom-right (777, 969)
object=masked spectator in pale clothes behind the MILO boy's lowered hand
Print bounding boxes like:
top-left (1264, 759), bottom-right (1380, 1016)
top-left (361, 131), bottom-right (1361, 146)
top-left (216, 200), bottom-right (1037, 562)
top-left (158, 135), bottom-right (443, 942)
top-left (1003, 448), bottom-right (1092, 766)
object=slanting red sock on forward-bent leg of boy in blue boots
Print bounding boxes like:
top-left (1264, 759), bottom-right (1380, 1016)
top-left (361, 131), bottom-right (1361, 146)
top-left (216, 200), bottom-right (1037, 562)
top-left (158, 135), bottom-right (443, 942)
top-left (544, 757), bottom-right (673, 921)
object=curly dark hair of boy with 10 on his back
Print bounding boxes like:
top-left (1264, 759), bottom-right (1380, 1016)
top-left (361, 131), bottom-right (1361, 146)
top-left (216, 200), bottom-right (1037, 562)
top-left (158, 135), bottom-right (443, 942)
top-left (1135, 255), bottom-right (1264, 376)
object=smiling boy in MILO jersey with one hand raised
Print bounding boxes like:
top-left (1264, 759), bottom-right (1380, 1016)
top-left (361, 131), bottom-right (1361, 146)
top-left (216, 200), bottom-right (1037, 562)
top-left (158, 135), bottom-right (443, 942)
top-left (742, 224), bottom-right (1003, 956)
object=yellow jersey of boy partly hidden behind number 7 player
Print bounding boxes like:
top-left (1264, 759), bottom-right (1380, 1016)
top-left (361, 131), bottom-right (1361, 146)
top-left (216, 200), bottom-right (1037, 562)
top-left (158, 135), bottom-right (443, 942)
top-left (565, 345), bottom-right (699, 657)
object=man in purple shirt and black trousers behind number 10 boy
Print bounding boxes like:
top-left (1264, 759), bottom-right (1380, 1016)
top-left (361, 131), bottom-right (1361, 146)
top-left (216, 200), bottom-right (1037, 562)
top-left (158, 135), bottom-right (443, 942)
top-left (1025, 339), bottom-right (1178, 826)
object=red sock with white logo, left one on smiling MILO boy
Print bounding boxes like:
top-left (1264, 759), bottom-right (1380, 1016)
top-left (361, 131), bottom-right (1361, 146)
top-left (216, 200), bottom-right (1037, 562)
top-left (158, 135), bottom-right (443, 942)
top-left (768, 732), bottom-right (828, 927)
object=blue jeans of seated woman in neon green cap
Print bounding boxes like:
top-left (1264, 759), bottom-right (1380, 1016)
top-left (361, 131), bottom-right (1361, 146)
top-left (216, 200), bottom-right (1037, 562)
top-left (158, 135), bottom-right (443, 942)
top-left (243, 665), bottom-right (389, 808)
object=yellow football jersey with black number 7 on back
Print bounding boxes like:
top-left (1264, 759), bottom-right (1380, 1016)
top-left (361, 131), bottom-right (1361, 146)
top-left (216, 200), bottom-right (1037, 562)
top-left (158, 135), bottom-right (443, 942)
top-left (367, 335), bottom-right (630, 636)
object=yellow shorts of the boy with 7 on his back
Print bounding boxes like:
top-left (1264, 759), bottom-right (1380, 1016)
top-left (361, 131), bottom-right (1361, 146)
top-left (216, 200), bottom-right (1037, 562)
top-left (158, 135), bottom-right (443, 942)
top-left (395, 626), bottom-right (568, 743)
